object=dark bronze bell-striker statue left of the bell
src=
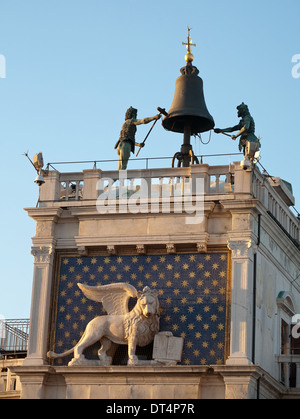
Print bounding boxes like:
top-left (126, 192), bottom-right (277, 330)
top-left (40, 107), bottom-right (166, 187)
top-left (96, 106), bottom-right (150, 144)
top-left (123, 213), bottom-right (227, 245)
top-left (115, 106), bottom-right (161, 170)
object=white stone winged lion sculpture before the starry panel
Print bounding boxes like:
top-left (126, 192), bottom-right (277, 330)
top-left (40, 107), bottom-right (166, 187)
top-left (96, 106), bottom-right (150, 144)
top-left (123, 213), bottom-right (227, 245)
top-left (47, 283), bottom-right (159, 366)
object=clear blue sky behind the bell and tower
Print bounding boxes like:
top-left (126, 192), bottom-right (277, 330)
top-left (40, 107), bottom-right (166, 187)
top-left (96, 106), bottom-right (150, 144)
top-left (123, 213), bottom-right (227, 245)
top-left (0, 0), bottom-right (300, 318)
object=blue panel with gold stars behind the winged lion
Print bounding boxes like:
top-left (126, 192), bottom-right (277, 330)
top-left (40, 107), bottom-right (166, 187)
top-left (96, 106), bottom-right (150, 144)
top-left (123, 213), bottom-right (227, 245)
top-left (50, 252), bottom-right (230, 365)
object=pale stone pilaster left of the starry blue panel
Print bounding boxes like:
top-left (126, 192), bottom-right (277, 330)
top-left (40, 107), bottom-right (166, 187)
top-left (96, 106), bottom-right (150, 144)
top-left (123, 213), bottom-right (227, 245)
top-left (23, 246), bottom-right (54, 366)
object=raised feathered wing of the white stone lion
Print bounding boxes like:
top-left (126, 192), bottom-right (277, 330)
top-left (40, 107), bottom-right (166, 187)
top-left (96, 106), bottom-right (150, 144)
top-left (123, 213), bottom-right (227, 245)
top-left (77, 282), bottom-right (137, 315)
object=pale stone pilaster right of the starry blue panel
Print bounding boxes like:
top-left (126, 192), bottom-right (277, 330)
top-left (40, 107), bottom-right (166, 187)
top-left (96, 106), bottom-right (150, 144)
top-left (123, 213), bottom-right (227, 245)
top-left (226, 240), bottom-right (256, 365)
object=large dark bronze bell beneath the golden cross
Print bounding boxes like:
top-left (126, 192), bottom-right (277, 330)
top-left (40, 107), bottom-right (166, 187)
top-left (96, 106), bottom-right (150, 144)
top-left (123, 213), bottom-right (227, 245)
top-left (162, 64), bottom-right (215, 135)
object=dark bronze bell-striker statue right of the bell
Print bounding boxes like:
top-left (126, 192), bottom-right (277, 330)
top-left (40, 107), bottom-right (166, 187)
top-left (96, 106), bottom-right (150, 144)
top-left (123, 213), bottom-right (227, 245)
top-left (214, 102), bottom-right (260, 155)
